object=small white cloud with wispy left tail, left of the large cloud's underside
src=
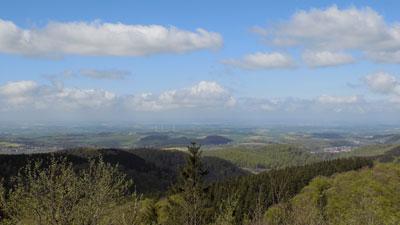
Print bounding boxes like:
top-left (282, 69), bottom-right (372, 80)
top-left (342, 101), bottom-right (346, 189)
top-left (220, 52), bottom-right (296, 70)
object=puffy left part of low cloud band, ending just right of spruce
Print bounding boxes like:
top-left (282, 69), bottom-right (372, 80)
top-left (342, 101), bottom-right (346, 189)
top-left (0, 81), bottom-right (236, 111)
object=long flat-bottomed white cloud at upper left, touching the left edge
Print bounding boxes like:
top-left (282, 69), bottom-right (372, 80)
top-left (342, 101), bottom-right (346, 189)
top-left (0, 19), bottom-right (222, 56)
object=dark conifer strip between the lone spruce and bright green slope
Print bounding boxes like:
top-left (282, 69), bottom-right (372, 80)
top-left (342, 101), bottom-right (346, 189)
top-left (207, 158), bottom-right (372, 224)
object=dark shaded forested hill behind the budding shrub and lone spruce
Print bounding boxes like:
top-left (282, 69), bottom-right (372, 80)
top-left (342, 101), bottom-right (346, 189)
top-left (0, 148), bottom-right (248, 193)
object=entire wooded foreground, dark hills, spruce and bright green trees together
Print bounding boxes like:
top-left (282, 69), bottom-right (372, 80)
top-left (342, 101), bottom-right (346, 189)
top-left (0, 143), bottom-right (400, 225)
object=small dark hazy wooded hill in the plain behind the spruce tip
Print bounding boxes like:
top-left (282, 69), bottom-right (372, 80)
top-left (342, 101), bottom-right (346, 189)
top-left (138, 134), bottom-right (232, 147)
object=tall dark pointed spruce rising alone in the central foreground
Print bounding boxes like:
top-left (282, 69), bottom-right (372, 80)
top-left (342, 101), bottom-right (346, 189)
top-left (172, 142), bottom-right (208, 225)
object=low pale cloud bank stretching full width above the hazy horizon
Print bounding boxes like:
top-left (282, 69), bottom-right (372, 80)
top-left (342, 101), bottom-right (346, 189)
top-left (0, 78), bottom-right (400, 121)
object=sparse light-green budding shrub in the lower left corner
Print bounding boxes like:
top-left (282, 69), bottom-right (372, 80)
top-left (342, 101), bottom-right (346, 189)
top-left (3, 156), bottom-right (138, 224)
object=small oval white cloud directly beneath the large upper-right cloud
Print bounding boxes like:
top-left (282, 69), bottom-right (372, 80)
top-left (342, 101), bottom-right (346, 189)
top-left (301, 51), bottom-right (356, 67)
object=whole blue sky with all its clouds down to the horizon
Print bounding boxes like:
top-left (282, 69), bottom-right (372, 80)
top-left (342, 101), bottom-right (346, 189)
top-left (0, 0), bottom-right (400, 124)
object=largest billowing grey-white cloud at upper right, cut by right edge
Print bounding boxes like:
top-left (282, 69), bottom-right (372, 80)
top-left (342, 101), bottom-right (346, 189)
top-left (256, 5), bottom-right (400, 66)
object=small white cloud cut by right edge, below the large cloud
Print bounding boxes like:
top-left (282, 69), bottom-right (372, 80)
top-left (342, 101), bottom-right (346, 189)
top-left (363, 72), bottom-right (400, 95)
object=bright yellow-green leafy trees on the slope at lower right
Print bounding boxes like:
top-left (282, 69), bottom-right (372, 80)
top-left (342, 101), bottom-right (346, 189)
top-left (265, 163), bottom-right (400, 224)
